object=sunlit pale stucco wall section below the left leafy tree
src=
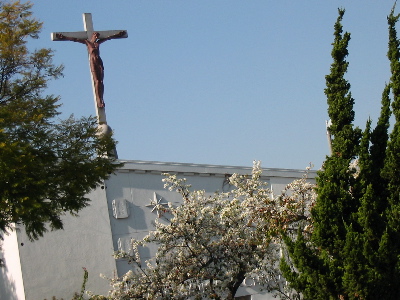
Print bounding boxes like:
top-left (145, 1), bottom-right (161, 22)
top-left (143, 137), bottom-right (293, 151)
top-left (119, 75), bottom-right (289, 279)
top-left (5, 186), bottom-right (116, 300)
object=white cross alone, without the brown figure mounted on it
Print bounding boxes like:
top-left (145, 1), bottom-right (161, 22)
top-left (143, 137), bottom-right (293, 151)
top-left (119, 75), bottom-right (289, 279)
top-left (51, 13), bottom-right (128, 125)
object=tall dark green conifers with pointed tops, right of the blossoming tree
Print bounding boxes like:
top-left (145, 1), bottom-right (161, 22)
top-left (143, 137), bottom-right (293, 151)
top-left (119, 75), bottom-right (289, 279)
top-left (281, 8), bottom-right (400, 300)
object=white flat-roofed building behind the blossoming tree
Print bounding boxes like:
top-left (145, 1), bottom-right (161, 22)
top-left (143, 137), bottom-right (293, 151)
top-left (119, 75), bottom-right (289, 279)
top-left (0, 161), bottom-right (315, 300)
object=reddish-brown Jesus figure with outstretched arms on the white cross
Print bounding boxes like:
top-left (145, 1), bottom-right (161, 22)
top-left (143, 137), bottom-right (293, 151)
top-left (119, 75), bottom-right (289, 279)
top-left (56, 31), bottom-right (126, 107)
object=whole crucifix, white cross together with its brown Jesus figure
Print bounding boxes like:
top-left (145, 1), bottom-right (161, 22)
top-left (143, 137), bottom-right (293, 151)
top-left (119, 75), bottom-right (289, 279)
top-left (51, 13), bottom-right (128, 126)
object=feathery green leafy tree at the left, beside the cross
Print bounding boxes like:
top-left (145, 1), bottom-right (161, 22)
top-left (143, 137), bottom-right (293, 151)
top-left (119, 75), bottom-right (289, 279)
top-left (0, 1), bottom-right (118, 239)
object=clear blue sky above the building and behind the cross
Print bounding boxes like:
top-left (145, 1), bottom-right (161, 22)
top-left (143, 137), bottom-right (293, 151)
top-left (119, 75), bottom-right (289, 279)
top-left (32, 0), bottom-right (400, 169)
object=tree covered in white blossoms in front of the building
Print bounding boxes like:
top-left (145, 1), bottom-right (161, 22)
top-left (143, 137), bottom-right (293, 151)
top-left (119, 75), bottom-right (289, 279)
top-left (101, 162), bottom-right (312, 299)
